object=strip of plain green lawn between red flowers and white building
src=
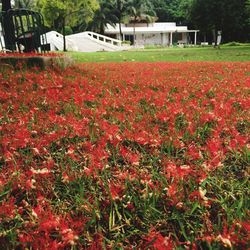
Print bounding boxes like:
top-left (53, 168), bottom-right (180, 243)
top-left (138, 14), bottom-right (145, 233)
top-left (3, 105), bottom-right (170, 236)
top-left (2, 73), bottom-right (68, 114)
top-left (68, 44), bottom-right (250, 63)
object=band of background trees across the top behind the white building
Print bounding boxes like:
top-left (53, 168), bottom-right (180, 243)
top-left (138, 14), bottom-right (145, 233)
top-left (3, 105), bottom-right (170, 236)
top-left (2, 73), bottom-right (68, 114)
top-left (0, 0), bottom-right (250, 42)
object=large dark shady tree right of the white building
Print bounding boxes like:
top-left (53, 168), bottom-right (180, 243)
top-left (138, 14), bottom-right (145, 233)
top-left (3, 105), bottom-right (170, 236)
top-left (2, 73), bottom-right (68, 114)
top-left (190, 0), bottom-right (250, 45)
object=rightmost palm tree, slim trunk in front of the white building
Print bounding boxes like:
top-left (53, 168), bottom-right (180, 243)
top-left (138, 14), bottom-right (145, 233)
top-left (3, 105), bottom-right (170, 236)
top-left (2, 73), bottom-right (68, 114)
top-left (128, 0), bottom-right (155, 46)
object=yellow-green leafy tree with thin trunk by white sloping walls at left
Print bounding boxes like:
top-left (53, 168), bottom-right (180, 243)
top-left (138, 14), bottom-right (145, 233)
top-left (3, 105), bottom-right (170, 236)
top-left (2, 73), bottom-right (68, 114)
top-left (38, 0), bottom-right (99, 51)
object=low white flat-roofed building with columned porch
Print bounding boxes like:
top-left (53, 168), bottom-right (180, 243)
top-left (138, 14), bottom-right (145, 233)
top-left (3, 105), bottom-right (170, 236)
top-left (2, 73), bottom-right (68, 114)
top-left (105, 23), bottom-right (199, 46)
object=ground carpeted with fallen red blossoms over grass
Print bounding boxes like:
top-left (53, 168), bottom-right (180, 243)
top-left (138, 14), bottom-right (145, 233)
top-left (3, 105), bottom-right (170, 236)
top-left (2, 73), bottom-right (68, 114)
top-left (0, 62), bottom-right (250, 250)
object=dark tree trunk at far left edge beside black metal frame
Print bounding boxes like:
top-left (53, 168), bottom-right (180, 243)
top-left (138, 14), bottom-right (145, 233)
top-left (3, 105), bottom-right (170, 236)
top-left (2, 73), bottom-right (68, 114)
top-left (2, 0), bottom-right (15, 51)
